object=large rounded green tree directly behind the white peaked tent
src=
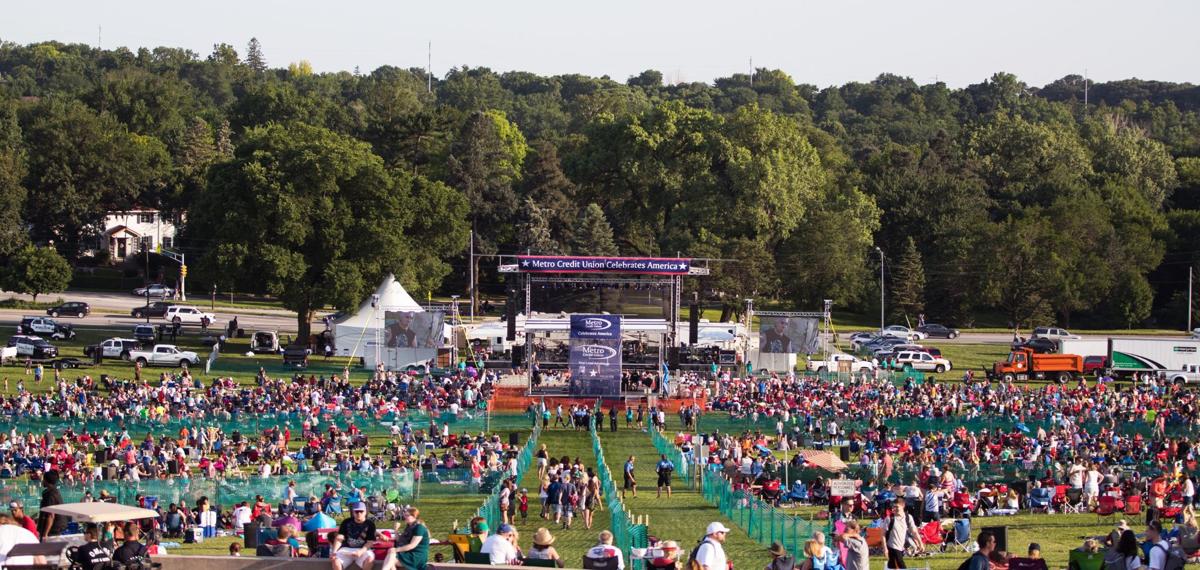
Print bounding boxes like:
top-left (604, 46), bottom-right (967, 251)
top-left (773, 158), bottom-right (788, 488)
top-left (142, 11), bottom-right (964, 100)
top-left (190, 124), bottom-right (412, 338)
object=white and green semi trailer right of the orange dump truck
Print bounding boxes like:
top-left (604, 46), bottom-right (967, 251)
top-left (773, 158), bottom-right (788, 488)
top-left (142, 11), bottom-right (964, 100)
top-left (1062, 337), bottom-right (1200, 378)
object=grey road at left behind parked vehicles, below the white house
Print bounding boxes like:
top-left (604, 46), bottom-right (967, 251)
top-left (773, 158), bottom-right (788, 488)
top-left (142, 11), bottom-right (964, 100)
top-left (0, 292), bottom-right (312, 334)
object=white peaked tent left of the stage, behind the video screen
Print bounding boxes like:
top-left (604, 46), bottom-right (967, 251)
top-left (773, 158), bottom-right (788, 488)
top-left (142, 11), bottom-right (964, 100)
top-left (334, 275), bottom-right (437, 370)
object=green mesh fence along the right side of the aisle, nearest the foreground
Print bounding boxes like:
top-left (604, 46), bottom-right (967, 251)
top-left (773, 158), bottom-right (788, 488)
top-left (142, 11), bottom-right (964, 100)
top-left (701, 470), bottom-right (833, 552)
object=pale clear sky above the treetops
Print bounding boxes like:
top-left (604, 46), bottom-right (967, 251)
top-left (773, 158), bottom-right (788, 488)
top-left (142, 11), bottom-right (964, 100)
top-left (0, 0), bottom-right (1200, 88)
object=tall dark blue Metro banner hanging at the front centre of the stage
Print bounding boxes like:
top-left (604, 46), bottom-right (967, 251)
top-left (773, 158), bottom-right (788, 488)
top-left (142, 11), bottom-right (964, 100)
top-left (569, 314), bottom-right (620, 396)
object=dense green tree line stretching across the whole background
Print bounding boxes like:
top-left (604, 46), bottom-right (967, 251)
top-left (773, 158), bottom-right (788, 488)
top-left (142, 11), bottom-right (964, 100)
top-left (0, 41), bottom-right (1200, 330)
